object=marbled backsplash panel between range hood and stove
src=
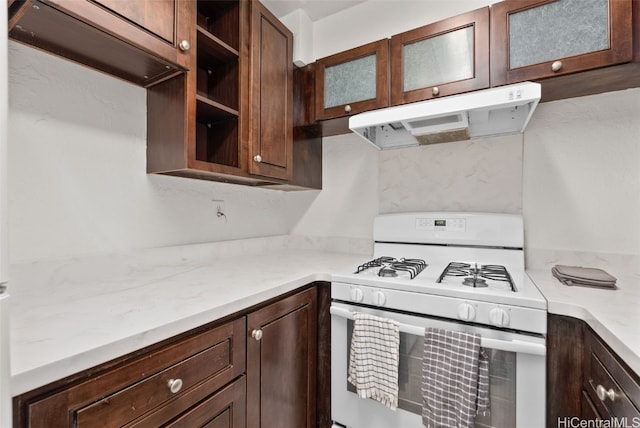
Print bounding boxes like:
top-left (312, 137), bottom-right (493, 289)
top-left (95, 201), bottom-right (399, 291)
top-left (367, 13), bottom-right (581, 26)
top-left (380, 135), bottom-right (522, 214)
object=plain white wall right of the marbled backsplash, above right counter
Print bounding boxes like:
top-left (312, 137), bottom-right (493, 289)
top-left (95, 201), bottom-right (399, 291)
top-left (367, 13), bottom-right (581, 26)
top-left (523, 88), bottom-right (640, 255)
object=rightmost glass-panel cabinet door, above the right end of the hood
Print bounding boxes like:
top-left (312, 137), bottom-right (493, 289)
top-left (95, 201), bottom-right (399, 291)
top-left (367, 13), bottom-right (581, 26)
top-left (491, 0), bottom-right (633, 86)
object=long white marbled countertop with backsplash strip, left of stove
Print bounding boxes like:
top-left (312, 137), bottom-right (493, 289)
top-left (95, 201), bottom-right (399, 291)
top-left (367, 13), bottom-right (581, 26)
top-left (10, 237), bottom-right (371, 396)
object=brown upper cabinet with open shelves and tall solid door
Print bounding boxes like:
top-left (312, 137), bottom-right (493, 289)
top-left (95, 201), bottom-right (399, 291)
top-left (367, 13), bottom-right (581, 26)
top-left (147, 0), bottom-right (293, 185)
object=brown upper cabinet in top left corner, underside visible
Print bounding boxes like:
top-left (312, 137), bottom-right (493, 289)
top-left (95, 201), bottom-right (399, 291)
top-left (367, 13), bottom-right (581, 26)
top-left (8, 0), bottom-right (195, 87)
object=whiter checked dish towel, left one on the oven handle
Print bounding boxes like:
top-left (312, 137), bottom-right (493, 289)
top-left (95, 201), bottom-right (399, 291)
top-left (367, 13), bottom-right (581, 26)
top-left (348, 313), bottom-right (400, 410)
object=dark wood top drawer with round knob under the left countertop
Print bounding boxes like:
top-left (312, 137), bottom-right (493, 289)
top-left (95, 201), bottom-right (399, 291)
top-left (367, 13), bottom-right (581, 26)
top-left (28, 317), bottom-right (246, 428)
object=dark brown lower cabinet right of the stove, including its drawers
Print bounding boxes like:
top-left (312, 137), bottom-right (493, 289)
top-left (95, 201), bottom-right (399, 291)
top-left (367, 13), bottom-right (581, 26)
top-left (547, 314), bottom-right (640, 428)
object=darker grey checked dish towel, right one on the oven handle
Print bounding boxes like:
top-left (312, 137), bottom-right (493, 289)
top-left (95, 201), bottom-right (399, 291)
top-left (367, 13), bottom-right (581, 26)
top-left (422, 328), bottom-right (489, 428)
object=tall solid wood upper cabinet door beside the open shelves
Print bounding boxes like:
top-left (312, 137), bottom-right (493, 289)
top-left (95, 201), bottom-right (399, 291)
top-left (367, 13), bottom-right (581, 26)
top-left (247, 1), bottom-right (293, 180)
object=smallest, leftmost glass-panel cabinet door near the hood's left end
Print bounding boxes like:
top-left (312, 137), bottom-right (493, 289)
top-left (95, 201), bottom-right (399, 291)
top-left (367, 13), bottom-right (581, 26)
top-left (315, 39), bottom-right (389, 120)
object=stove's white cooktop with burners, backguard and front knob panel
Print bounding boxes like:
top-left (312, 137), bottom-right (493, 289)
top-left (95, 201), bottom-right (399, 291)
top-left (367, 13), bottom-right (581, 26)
top-left (332, 212), bottom-right (547, 334)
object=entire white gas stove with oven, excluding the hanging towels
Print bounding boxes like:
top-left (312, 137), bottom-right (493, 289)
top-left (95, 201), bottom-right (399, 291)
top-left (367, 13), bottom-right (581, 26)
top-left (331, 212), bottom-right (547, 428)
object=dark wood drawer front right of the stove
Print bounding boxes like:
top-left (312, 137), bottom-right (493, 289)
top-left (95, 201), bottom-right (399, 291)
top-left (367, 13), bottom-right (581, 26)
top-left (585, 336), bottom-right (640, 420)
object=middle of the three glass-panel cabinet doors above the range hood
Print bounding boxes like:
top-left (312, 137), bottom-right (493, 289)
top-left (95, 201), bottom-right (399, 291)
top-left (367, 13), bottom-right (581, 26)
top-left (391, 7), bottom-right (489, 105)
